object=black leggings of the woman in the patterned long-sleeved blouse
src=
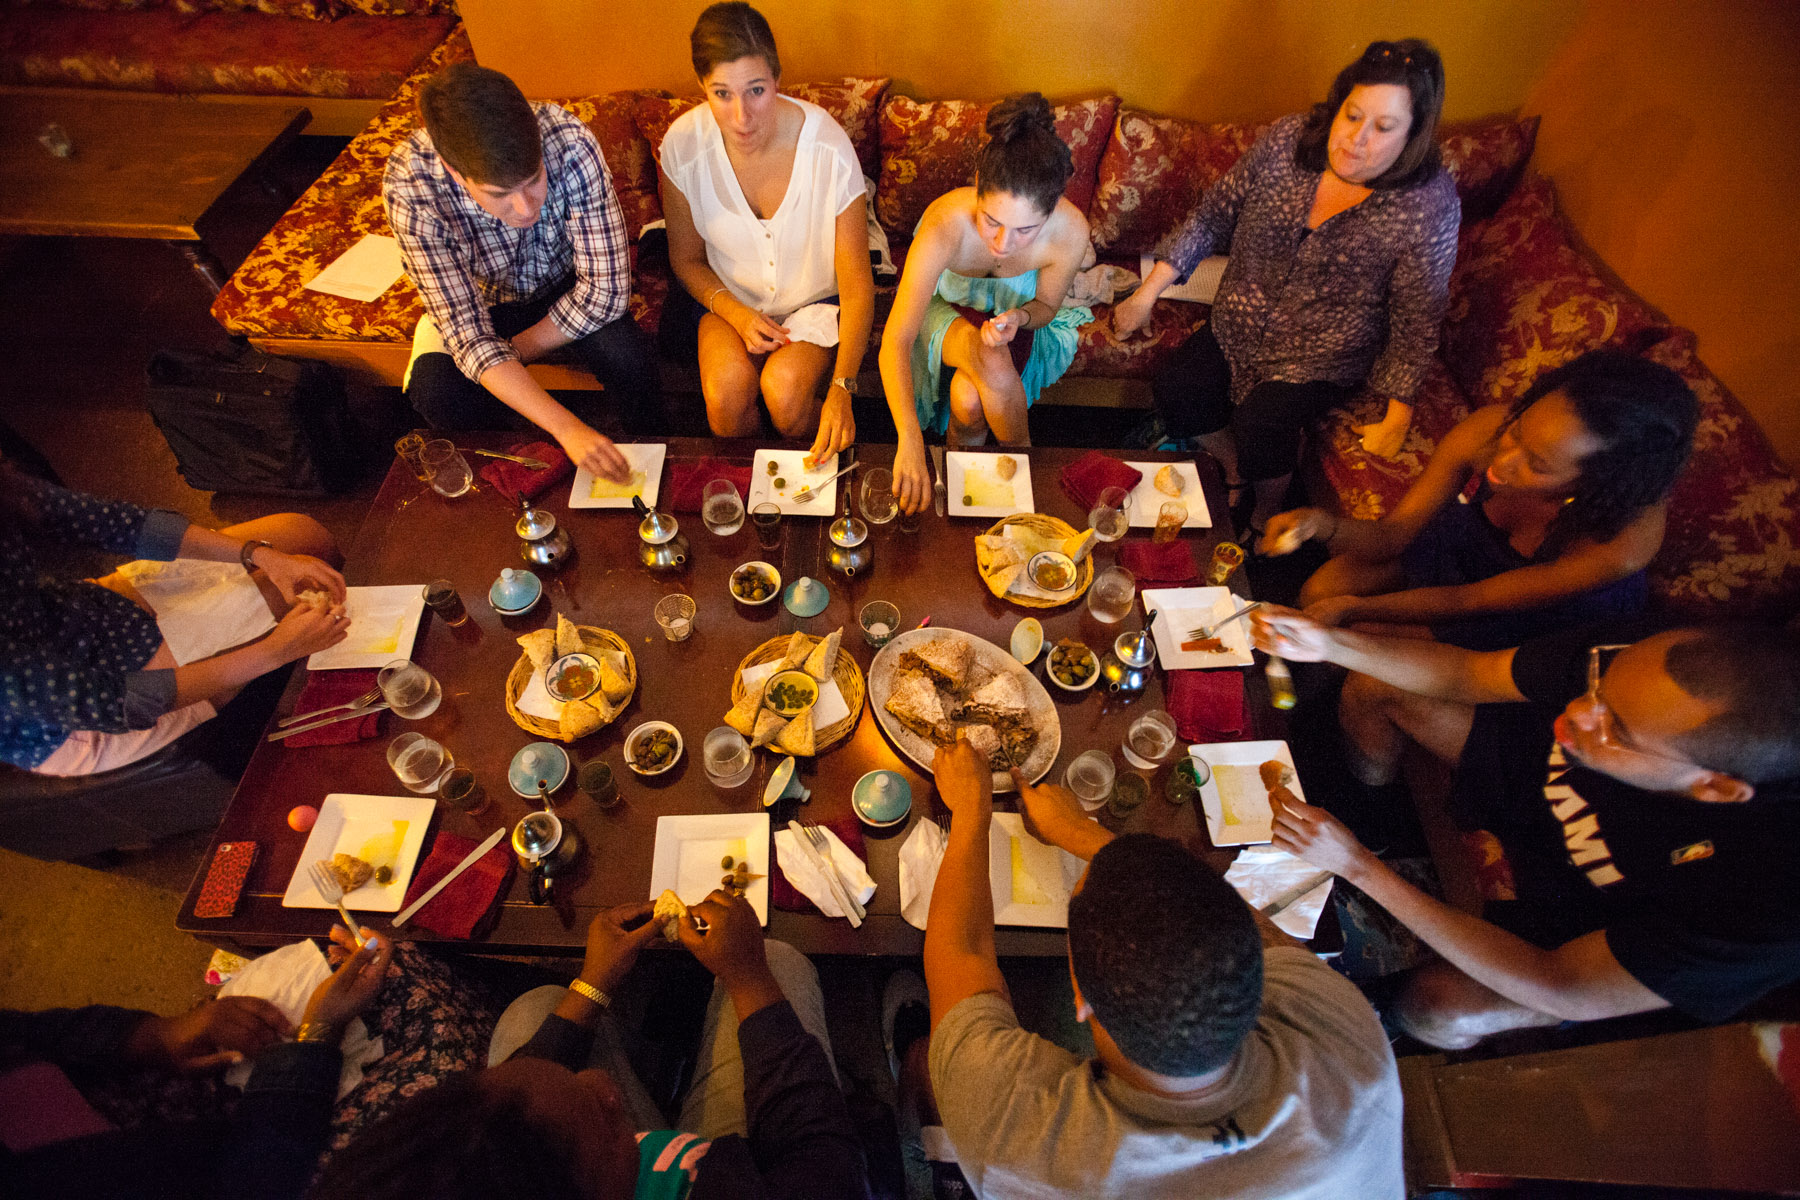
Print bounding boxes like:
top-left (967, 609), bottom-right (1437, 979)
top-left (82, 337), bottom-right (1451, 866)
top-left (1150, 324), bottom-right (1355, 482)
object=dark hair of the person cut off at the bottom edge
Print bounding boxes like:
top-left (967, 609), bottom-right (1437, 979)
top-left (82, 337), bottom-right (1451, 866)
top-left (306, 1070), bottom-right (587, 1200)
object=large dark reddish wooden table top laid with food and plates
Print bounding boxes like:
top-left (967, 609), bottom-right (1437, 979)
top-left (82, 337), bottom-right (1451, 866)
top-left (176, 435), bottom-right (1278, 955)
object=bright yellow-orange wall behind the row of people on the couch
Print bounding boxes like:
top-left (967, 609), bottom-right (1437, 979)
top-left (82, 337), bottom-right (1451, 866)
top-left (457, 0), bottom-right (1580, 121)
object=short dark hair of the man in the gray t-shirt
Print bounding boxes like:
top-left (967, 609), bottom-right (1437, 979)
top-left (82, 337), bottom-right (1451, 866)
top-left (1069, 833), bottom-right (1262, 1076)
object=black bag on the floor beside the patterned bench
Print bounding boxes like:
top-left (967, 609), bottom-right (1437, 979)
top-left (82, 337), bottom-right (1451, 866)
top-left (146, 347), bottom-right (355, 497)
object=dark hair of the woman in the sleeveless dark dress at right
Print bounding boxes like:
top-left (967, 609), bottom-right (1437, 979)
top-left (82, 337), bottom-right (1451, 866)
top-left (1507, 351), bottom-right (1699, 558)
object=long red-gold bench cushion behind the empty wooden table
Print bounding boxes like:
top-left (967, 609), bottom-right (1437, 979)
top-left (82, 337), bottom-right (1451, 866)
top-left (0, 9), bottom-right (455, 99)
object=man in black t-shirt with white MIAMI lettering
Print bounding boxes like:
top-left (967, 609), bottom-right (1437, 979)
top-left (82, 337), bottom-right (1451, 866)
top-left (1255, 608), bottom-right (1800, 1049)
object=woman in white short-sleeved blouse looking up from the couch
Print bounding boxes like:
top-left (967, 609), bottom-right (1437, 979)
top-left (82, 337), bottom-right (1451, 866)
top-left (661, 4), bottom-right (875, 461)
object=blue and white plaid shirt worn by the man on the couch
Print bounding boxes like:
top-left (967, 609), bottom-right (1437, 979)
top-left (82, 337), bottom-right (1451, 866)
top-left (382, 104), bottom-right (632, 381)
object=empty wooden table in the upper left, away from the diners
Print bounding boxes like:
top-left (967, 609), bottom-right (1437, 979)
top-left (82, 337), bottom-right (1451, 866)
top-left (0, 88), bottom-right (311, 295)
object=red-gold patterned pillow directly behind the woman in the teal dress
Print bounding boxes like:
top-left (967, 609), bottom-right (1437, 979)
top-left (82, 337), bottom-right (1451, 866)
top-left (875, 95), bottom-right (1120, 239)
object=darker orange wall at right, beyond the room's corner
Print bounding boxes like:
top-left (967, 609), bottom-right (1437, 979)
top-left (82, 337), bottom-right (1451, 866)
top-left (1525, 0), bottom-right (1800, 464)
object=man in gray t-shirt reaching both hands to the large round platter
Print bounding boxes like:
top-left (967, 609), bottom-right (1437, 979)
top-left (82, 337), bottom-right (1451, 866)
top-left (925, 743), bottom-right (1404, 1200)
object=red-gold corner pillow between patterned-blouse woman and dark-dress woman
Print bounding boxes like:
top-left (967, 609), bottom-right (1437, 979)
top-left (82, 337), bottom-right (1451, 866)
top-left (1442, 176), bottom-right (1670, 405)
